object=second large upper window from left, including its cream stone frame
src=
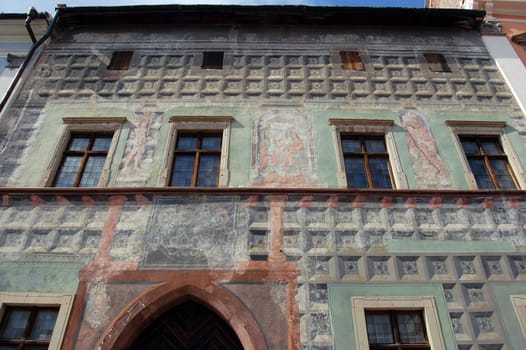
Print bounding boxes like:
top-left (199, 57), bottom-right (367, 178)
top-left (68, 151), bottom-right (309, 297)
top-left (163, 116), bottom-right (233, 187)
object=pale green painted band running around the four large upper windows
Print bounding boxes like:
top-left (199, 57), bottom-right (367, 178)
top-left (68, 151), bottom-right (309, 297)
top-left (20, 101), bottom-right (526, 189)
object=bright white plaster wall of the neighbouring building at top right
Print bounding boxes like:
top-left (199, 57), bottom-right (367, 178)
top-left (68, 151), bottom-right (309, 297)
top-left (482, 36), bottom-right (526, 114)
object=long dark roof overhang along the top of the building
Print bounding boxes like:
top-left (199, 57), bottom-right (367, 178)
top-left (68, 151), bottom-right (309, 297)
top-left (53, 5), bottom-right (485, 29)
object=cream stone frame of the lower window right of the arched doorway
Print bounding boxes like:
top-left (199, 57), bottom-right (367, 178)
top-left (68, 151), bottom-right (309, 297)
top-left (351, 296), bottom-right (446, 350)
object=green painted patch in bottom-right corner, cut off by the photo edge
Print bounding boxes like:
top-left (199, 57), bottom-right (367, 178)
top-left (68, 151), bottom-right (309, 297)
top-left (490, 283), bottom-right (526, 349)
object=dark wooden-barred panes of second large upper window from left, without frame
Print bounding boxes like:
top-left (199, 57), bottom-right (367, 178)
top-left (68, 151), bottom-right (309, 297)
top-left (170, 133), bottom-right (222, 187)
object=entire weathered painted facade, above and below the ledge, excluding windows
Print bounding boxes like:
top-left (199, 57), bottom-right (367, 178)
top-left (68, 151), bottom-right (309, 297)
top-left (0, 15), bottom-right (526, 350)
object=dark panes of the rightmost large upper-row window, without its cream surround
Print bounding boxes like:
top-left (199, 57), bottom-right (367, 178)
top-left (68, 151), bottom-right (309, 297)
top-left (459, 136), bottom-right (517, 190)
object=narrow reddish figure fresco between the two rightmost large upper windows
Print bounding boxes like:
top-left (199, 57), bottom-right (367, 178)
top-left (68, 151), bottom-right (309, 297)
top-left (399, 111), bottom-right (451, 189)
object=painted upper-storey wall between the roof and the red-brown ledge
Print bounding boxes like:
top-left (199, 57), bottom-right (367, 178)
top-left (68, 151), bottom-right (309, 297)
top-left (0, 23), bottom-right (526, 189)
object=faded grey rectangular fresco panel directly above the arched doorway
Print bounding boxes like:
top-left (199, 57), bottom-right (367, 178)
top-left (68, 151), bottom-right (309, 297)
top-left (142, 197), bottom-right (242, 268)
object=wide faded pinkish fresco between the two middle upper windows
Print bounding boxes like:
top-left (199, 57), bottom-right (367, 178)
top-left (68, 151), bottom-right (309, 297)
top-left (252, 109), bottom-right (317, 187)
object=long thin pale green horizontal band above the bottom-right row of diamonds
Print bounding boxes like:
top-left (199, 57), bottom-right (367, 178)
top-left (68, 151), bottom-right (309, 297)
top-left (387, 239), bottom-right (516, 254)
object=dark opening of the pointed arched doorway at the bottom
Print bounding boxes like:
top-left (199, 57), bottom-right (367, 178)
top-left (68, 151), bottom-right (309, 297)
top-left (129, 300), bottom-right (243, 350)
